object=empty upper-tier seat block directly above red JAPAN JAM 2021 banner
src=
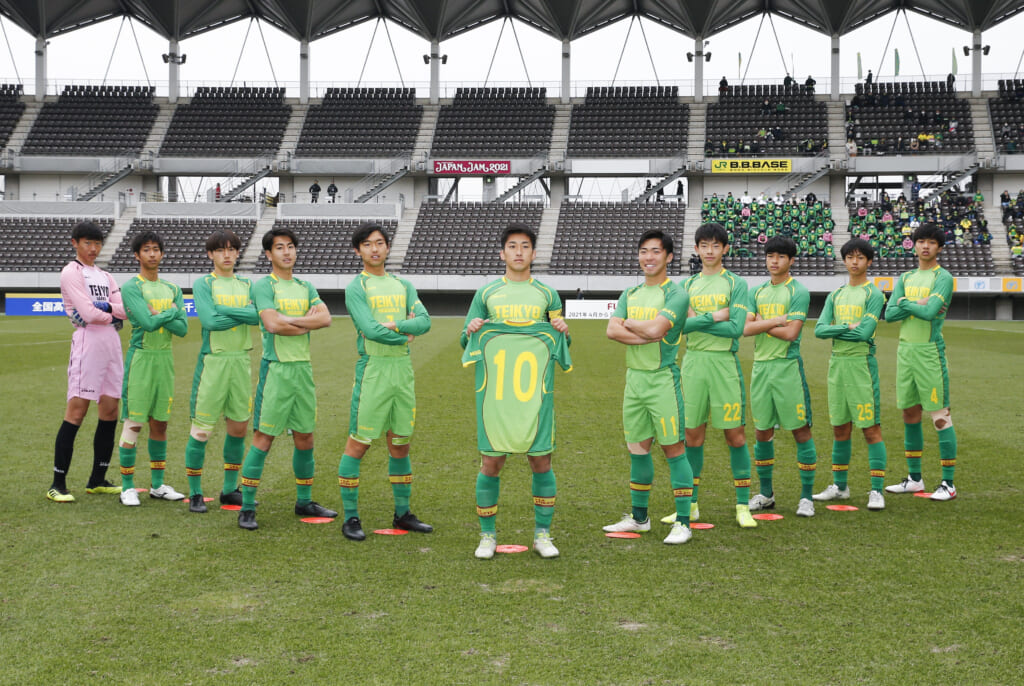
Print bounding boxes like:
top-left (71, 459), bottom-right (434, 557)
top-left (431, 88), bottom-right (555, 158)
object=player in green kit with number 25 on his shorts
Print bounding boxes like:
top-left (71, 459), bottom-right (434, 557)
top-left (814, 239), bottom-right (886, 510)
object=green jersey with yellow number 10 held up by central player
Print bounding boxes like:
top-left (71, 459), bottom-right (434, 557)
top-left (462, 321), bottom-right (572, 454)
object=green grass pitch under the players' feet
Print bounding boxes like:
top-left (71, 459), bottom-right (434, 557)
top-left (0, 317), bottom-right (1024, 685)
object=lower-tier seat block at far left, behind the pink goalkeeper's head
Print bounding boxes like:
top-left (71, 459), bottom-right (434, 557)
top-left (0, 216), bottom-right (114, 271)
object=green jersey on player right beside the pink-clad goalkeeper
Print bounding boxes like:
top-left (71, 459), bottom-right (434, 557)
top-left (121, 274), bottom-right (188, 350)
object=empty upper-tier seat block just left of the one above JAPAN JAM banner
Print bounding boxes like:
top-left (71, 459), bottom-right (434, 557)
top-left (295, 88), bottom-right (423, 158)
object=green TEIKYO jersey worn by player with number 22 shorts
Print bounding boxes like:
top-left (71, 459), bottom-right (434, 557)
top-left (681, 267), bottom-right (749, 352)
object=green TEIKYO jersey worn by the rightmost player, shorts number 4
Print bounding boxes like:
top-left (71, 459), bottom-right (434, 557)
top-left (886, 265), bottom-right (953, 347)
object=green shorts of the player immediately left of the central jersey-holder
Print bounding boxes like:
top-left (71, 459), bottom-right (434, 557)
top-left (348, 355), bottom-right (416, 444)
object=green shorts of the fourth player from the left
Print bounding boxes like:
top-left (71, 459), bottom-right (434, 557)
top-left (253, 359), bottom-right (316, 436)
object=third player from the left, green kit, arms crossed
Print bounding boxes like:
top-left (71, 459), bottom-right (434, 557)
top-left (185, 229), bottom-right (259, 513)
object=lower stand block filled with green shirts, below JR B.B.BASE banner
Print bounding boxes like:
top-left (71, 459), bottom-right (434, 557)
top-left (700, 192), bottom-right (836, 275)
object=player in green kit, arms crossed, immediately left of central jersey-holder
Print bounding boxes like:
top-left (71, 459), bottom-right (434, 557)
top-left (338, 223), bottom-right (434, 541)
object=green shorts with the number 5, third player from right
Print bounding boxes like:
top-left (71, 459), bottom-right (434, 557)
top-left (751, 357), bottom-right (811, 431)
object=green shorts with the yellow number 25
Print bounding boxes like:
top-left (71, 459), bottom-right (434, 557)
top-left (828, 355), bottom-right (882, 429)
